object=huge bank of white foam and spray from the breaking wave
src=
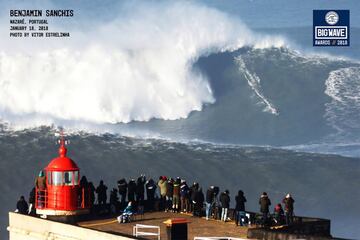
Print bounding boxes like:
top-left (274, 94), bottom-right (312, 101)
top-left (0, 3), bottom-right (285, 126)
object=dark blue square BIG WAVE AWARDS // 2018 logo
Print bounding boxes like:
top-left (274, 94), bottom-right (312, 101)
top-left (313, 10), bottom-right (350, 46)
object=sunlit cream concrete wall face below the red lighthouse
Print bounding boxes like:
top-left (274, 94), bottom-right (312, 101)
top-left (7, 212), bottom-right (134, 240)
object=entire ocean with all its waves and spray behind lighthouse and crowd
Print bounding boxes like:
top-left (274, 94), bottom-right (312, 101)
top-left (0, 0), bottom-right (360, 239)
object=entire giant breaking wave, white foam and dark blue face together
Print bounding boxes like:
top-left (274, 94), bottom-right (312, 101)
top-left (0, 0), bottom-right (360, 148)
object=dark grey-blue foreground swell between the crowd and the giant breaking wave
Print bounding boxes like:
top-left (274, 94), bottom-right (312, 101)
top-left (0, 127), bottom-right (360, 239)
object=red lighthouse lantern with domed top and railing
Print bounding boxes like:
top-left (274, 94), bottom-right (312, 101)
top-left (35, 138), bottom-right (90, 216)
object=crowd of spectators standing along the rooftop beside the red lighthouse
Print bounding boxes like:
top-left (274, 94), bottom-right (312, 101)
top-left (16, 172), bottom-right (295, 226)
